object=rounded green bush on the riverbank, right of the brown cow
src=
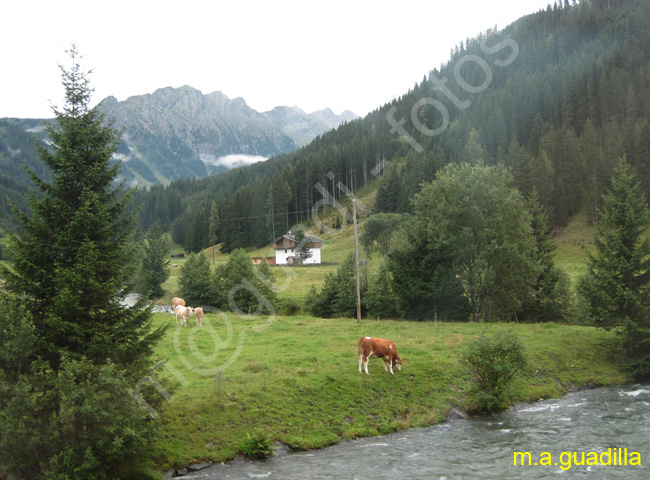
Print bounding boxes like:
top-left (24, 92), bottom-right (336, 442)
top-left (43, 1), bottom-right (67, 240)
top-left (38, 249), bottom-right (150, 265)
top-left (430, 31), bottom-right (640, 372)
top-left (460, 332), bottom-right (526, 412)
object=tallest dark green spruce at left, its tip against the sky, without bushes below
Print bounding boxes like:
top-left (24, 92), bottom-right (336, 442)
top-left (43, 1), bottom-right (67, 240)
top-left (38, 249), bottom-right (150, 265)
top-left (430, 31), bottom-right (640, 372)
top-left (2, 47), bottom-right (160, 368)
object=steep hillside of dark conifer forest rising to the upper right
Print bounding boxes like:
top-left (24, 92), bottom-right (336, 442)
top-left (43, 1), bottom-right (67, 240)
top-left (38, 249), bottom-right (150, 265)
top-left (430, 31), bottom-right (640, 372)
top-left (139, 0), bottom-right (650, 255)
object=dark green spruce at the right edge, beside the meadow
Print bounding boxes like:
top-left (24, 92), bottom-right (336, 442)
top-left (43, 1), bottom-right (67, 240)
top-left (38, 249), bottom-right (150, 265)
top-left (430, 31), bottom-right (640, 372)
top-left (578, 159), bottom-right (650, 378)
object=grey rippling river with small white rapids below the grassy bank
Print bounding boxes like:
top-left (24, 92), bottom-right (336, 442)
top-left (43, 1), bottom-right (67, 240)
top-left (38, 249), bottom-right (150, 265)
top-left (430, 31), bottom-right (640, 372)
top-left (182, 385), bottom-right (650, 480)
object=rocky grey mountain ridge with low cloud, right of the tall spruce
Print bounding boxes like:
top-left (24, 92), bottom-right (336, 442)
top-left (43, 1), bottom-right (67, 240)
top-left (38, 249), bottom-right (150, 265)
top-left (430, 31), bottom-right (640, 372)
top-left (99, 85), bottom-right (358, 185)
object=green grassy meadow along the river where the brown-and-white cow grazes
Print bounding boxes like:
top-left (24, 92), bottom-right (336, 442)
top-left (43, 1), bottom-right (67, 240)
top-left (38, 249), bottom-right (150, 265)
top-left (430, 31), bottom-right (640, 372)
top-left (148, 313), bottom-right (629, 470)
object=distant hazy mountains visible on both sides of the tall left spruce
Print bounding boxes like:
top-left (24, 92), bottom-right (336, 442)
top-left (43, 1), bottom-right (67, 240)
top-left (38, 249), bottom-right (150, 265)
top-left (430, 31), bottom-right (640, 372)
top-left (0, 91), bottom-right (357, 229)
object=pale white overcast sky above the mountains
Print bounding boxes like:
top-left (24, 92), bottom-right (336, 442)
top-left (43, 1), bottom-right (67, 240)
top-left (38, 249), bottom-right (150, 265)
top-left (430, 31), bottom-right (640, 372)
top-left (0, 0), bottom-right (549, 118)
